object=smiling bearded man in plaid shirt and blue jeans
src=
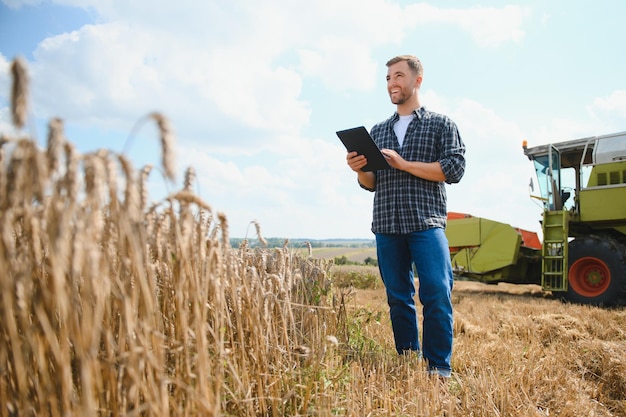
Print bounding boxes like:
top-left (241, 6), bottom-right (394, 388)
top-left (347, 55), bottom-right (465, 377)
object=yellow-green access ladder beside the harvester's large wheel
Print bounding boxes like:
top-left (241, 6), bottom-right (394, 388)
top-left (541, 210), bottom-right (569, 291)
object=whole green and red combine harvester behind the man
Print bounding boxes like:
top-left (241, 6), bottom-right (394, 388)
top-left (446, 132), bottom-right (626, 306)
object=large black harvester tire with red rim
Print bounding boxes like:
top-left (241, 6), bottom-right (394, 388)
top-left (565, 235), bottom-right (626, 306)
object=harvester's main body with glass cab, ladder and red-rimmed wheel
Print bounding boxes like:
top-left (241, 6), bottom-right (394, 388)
top-left (523, 132), bottom-right (626, 305)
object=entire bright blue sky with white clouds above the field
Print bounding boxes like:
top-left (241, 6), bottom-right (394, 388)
top-left (0, 0), bottom-right (626, 239)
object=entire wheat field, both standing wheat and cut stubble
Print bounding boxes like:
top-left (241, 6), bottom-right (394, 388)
top-left (0, 56), bottom-right (626, 416)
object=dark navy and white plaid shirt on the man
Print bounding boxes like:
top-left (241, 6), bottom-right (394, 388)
top-left (363, 107), bottom-right (465, 234)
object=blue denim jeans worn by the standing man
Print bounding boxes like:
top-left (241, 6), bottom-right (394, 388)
top-left (376, 228), bottom-right (454, 376)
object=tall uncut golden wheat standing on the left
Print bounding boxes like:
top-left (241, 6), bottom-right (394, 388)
top-left (0, 59), bottom-right (338, 415)
